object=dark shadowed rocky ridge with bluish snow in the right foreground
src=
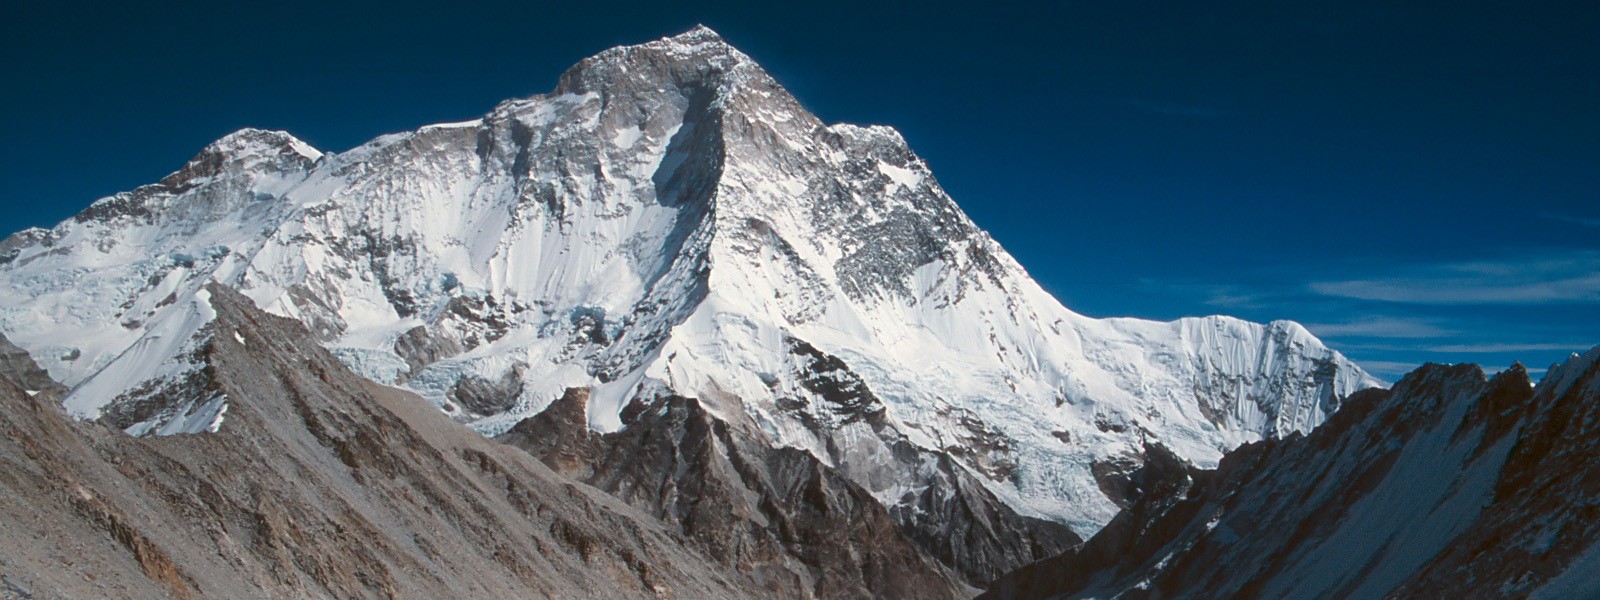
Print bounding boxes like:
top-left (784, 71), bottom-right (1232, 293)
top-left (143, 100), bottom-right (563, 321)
top-left (984, 347), bottom-right (1600, 598)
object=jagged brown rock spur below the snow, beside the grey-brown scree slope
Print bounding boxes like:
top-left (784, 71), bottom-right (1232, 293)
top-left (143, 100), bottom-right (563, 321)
top-left (499, 389), bottom-right (966, 600)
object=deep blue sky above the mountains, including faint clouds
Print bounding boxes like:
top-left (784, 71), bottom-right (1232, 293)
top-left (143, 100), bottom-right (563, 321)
top-left (0, 0), bottom-right (1600, 378)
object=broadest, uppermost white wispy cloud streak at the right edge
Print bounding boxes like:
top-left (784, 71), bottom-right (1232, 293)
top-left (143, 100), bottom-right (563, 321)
top-left (1307, 251), bottom-right (1600, 304)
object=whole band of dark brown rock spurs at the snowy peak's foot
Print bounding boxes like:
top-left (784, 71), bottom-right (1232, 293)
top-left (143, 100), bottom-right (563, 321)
top-left (499, 389), bottom-right (1075, 598)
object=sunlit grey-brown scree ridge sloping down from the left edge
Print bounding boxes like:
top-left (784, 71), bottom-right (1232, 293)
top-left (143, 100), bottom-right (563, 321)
top-left (0, 286), bottom-right (757, 598)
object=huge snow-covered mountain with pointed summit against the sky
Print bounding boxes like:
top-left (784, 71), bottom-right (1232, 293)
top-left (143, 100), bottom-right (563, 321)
top-left (0, 27), bottom-right (1379, 533)
